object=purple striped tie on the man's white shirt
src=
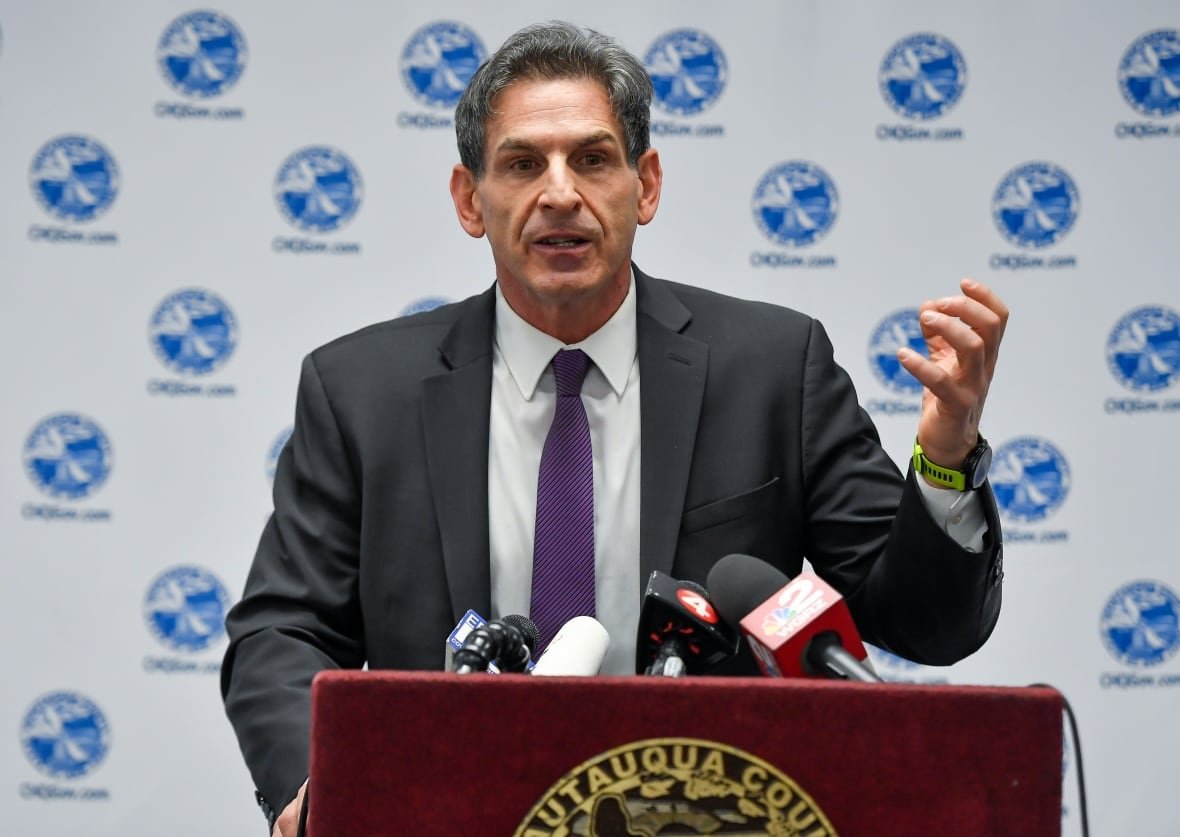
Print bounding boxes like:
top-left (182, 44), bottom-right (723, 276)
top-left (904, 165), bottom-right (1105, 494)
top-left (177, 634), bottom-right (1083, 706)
top-left (529, 349), bottom-right (595, 650)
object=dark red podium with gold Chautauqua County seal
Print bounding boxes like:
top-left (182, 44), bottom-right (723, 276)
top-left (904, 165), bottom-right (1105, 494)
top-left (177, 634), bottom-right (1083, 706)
top-left (309, 672), bottom-right (1062, 837)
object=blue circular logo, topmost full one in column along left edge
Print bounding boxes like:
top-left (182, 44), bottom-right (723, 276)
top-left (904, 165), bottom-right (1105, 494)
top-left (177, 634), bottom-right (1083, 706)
top-left (28, 135), bottom-right (119, 222)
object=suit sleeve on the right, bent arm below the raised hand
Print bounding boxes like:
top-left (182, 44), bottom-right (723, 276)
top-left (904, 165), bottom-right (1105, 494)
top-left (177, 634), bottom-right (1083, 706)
top-left (800, 321), bottom-right (1003, 665)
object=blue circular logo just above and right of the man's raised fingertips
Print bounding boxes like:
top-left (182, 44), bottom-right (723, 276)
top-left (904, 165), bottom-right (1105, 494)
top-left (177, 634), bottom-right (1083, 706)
top-left (991, 163), bottom-right (1079, 248)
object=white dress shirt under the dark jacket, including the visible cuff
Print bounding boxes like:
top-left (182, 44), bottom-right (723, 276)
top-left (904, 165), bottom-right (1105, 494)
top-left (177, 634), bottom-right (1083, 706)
top-left (487, 275), bottom-right (986, 674)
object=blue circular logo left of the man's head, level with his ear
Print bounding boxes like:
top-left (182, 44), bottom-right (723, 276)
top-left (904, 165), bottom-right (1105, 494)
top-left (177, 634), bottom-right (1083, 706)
top-left (275, 145), bottom-right (365, 233)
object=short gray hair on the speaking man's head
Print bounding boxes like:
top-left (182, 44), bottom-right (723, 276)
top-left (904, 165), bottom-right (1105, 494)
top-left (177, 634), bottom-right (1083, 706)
top-left (454, 21), bottom-right (651, 179)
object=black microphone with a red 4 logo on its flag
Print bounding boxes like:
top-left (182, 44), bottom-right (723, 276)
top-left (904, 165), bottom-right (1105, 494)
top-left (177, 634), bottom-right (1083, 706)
top-left (635, 570), bottom-right (738, 678)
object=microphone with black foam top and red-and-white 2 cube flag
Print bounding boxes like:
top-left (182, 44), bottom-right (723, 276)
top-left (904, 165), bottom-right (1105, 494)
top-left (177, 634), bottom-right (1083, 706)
top-left (708, 555), bottom-right (881, 684)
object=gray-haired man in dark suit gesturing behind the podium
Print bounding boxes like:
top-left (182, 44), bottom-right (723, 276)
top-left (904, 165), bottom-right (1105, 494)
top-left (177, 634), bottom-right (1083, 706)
top-left (222, 24), bottom-right (1007, 835)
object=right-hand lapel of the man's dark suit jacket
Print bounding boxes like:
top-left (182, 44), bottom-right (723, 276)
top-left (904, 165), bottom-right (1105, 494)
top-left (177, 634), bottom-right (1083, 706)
top-left (635, 268), bottom-right (709, 594)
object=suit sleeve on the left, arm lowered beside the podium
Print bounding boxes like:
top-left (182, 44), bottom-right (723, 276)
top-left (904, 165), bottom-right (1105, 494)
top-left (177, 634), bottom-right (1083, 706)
top-left (221, 357), bottom-right (363, 811)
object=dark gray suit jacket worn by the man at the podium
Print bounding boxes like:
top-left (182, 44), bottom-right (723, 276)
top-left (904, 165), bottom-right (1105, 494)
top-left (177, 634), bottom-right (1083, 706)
top-left (222, 265), bottom-right (1002, 810)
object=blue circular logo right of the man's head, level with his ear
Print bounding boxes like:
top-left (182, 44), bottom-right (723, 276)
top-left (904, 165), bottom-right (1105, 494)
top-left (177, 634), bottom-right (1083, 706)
top-left (753, 159), bottom-right (840, 247)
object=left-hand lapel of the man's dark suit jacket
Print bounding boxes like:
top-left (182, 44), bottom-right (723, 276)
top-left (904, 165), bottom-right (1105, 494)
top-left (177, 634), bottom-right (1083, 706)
top-left (422, 288), bottom-right (496, 621)
